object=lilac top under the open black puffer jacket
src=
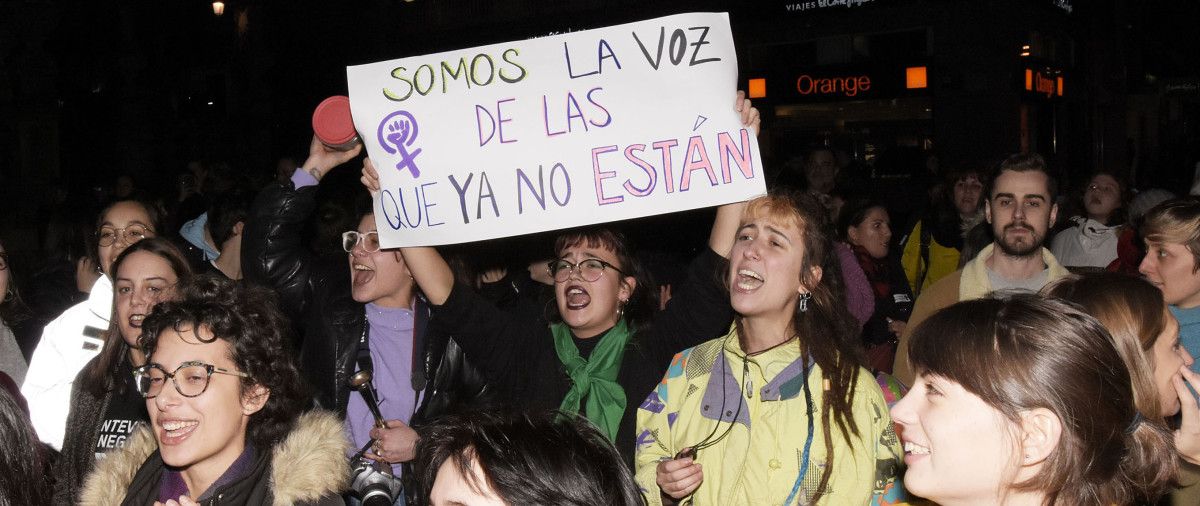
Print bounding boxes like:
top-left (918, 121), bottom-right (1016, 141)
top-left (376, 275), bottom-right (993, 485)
top-left (346, 303), bottom-right (420, 476)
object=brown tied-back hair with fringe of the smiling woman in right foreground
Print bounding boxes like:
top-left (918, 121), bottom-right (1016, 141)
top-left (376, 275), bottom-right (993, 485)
top-left (908, 294), bottom-right (1176, 505)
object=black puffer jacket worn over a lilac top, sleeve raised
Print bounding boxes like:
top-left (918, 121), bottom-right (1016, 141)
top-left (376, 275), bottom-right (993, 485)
top-left (241, 181), bottom-right (491, 427)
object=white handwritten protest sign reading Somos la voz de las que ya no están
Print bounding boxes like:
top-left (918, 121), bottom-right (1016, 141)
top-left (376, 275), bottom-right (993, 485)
top-left (347, 13), bottom-right (764, 247)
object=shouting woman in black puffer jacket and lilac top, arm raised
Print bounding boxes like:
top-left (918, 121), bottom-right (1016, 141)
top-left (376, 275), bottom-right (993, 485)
top-left (241, 137), bottom-right (492, 501)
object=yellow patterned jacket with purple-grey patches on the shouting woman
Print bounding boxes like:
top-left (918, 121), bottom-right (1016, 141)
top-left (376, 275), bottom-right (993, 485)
top-left (635, 330), bottom-right (905, 506)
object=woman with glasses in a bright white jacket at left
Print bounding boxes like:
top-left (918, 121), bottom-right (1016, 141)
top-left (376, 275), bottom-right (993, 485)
top-left (20, 200), bottom-right (162, 448)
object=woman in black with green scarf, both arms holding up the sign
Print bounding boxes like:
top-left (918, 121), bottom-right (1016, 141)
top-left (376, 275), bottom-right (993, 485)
top-left (362, 92), bottom-right (760, 463)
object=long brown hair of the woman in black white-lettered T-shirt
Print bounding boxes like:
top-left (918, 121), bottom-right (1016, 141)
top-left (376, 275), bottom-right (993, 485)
top-left (83, 237), bottom-right (192, 397)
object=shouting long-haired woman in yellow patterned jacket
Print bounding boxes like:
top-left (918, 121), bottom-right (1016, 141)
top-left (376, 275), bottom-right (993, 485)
top-left (636, 191), bottom-right (902, 505)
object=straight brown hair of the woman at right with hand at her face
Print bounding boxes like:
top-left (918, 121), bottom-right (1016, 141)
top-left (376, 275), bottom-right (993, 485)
top-left (1042, 272), bottom-right (1166, 420)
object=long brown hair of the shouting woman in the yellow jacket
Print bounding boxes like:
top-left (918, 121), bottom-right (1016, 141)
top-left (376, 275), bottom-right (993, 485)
top-left (726, 192), bottom-right (863, 502)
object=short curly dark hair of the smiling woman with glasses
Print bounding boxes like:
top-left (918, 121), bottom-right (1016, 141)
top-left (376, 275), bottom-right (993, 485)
top-left (139, 275), bottom-right (312, 448)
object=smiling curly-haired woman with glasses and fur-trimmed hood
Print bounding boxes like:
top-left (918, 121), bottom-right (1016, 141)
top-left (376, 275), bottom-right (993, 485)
top-left (80, 275), bottom-right (349, 506)
